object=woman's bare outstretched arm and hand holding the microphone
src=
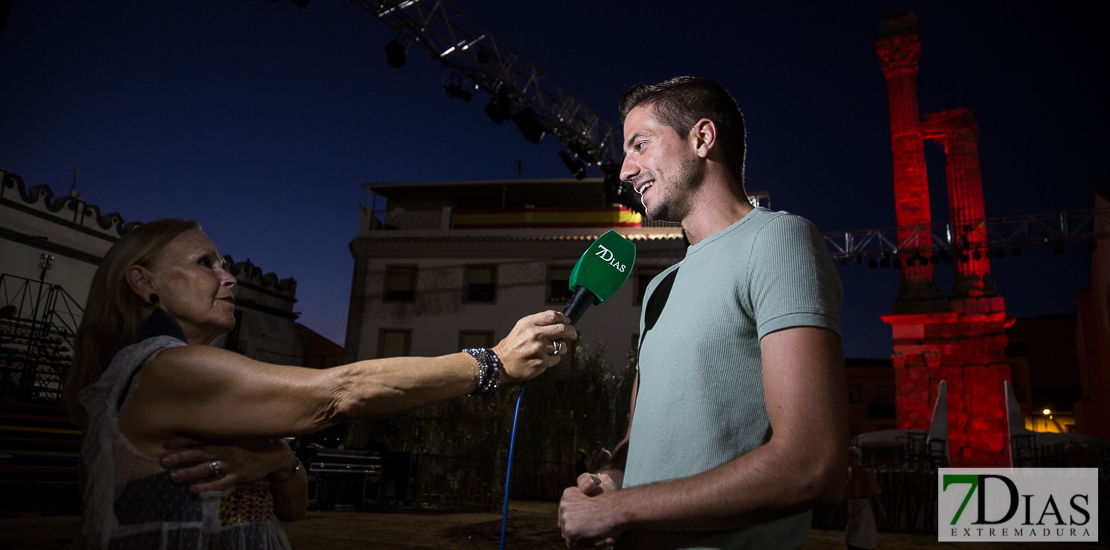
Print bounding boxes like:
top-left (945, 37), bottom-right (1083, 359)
top-left (120, 311), bottom-right (577, 446)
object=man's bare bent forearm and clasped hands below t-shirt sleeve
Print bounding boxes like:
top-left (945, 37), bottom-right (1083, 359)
top-left (559, 327), bottom-right (848, 546)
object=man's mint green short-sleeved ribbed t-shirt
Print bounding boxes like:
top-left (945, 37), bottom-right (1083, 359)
top-left (620, 208), bottom-right (842, 549)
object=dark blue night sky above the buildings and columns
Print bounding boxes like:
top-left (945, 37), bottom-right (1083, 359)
top-left (0, 0), bottom-right (1110, 358)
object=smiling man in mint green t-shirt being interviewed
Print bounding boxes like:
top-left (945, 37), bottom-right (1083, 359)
top-left (558, 77), bottom-right (848, 549)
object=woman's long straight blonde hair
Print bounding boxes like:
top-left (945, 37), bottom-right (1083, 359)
top-left (62, 219), bottom-right (201, 428)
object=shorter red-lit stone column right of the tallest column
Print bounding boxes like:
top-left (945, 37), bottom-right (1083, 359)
top-left (921, 109), bottom-right (995, 299)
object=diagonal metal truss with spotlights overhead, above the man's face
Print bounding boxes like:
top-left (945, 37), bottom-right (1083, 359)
top-left (351, 0), bottom-right (624, 167)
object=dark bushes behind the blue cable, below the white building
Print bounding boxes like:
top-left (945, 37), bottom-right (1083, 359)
top-left (346, 343), bottom-right (635, 510)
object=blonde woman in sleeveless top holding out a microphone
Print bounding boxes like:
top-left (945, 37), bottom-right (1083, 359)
top-left (65, 220), bottom-right (576, 549)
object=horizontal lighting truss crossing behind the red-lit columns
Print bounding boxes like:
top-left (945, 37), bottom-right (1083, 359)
top-left (825, 208), bottom-right (1110, 263)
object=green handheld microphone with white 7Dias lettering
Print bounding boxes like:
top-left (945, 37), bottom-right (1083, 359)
top-left (563, 230), bottom-right (636, 324)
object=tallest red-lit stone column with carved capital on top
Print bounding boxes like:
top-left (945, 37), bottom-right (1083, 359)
top-left (876, 12), bottom-right (944, 313)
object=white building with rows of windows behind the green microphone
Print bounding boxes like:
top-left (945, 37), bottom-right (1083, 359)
top-left (346, 178), bottom-right (686, 369)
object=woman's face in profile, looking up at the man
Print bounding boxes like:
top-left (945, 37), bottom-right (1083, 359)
top-left (143, 231), bottom-right (235, 344)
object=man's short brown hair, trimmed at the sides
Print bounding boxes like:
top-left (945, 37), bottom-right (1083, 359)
top-left (620, 77), bottom-right (746, 188)
